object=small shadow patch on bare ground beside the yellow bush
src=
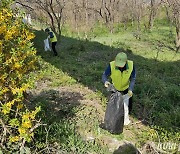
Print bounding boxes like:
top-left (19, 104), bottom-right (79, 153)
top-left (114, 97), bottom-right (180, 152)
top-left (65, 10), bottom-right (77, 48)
top-left (31, 89), bottom-right (82, 124)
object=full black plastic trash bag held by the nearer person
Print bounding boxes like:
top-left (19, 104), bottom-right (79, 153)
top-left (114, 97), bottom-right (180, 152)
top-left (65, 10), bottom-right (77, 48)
top-left (103, 85), bottom-right (124, 134)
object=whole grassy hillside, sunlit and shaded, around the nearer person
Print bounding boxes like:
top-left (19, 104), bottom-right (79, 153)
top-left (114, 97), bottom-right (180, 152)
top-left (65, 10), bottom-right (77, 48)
top-left (31, 26), bottom-right (180, 153)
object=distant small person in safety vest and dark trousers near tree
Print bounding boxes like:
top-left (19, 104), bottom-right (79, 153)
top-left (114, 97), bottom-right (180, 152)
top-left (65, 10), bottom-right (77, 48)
top-left (45, 28), bottom-right (58, 56)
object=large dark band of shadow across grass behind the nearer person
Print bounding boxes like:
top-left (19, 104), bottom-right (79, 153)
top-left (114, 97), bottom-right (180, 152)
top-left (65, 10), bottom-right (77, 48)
top-left (34, 31), bottom-right (180, 140)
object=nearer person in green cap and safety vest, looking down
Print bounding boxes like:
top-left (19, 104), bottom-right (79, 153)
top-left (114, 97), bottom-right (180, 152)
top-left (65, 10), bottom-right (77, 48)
top-left (102, 52), bottom-right (136, 113)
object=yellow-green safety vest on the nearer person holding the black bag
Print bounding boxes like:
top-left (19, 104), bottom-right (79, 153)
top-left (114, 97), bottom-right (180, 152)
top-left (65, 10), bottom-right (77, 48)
top-left (110, 60), bottom-right (133, 91)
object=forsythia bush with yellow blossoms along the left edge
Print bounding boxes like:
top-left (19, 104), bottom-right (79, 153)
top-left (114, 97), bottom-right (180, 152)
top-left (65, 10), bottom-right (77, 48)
top-left (0, 0), bottom-right (40, 150)
